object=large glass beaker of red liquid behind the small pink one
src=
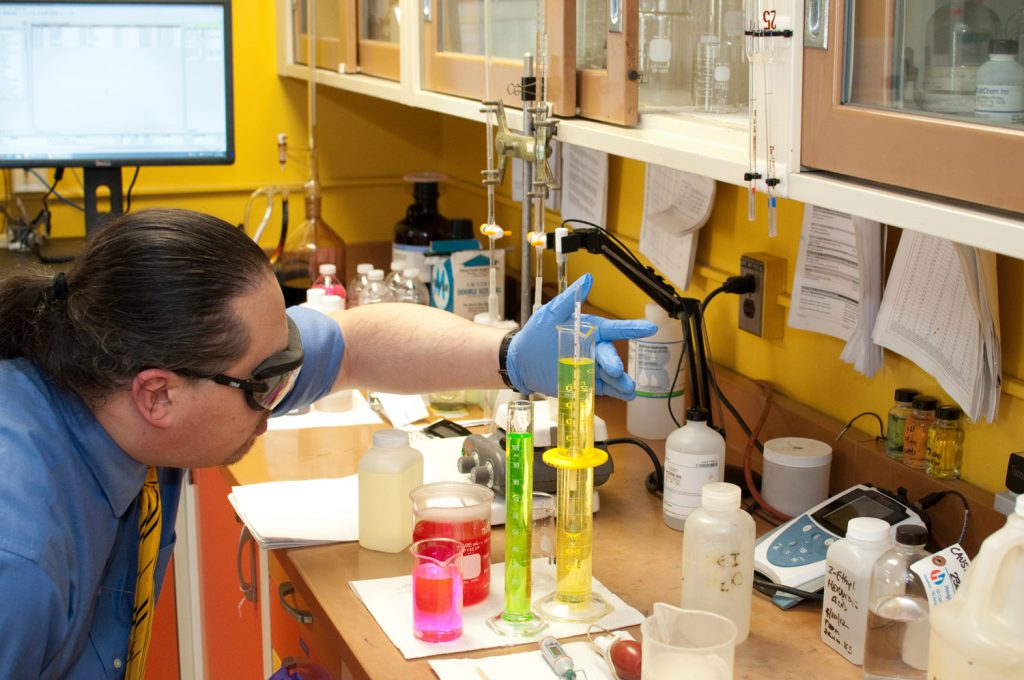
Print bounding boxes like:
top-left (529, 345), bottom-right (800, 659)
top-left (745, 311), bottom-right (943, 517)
top-left (409, 481), bottom-right (495, 606)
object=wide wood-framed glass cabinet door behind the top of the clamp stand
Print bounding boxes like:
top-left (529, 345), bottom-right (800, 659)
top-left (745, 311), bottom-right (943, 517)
top-left (420, 0), bottom-right (575, 116)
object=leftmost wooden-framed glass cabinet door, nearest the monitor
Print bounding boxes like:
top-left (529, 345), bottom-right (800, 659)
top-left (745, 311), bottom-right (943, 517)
top-left (292, 0), bottom-right (356, 73)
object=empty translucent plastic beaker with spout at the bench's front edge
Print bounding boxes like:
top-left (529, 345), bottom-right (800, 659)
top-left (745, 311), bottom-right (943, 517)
top-left (640, 602), bottom-right (736, 680)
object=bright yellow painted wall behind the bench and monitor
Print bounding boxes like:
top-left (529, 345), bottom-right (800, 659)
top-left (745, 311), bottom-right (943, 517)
top-left (12, 0), bottom-right (1024, 492)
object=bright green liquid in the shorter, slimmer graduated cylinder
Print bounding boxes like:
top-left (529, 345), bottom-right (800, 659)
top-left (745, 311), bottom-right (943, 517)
top-left (502, 432), bottom-right (534, 622)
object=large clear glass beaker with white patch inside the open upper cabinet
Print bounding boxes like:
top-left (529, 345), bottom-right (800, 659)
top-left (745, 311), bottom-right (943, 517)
top-left (639, 0), bottom-right (696, 111)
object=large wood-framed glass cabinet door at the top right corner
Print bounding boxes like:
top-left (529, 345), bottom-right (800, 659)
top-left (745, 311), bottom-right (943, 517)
top-left (802, 0), bottom-right (1024, 212)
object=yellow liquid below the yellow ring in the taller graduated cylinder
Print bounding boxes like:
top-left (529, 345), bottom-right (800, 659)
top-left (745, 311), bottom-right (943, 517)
top-left (555, 468), bottom-right (594, 602)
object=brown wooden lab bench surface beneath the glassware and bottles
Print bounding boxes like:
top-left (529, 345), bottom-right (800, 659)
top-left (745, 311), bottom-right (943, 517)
top-left (221, 398), bottom-right (861, 680)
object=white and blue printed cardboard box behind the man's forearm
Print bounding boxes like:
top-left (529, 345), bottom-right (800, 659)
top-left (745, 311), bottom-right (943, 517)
top-left (430, 250), bottom-right (505, 321)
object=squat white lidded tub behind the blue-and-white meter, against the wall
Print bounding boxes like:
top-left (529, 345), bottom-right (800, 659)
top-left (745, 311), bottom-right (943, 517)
top-left (761, 437), bottom-right (831, 517)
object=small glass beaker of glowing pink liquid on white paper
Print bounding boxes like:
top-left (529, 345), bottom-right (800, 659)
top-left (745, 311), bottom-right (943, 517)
top-left (409, 539), bottom-right (464, 642)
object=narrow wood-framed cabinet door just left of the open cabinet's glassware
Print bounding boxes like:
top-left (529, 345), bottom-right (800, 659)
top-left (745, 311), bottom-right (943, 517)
top-left (575, 0), bottom-right (640, 125)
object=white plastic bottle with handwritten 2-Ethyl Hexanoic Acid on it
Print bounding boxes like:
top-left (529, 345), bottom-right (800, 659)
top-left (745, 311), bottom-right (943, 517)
top-left (821, 517), bottom-right (892, 666)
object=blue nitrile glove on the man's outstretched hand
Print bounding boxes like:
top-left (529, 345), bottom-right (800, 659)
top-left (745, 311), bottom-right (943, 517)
top-left (507, 273), bottom-right (657, 400)
